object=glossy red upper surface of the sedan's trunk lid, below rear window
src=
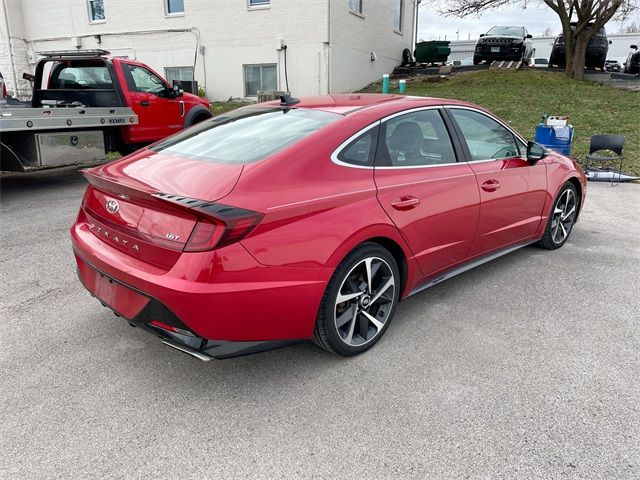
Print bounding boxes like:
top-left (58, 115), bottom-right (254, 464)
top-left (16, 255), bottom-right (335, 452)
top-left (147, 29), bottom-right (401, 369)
top-left (86, 149), bottom-right (244, 202)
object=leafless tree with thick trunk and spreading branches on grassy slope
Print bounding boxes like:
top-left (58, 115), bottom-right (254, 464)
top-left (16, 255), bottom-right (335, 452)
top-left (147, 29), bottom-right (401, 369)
top-left (441, 0), bottom-right (640, 78)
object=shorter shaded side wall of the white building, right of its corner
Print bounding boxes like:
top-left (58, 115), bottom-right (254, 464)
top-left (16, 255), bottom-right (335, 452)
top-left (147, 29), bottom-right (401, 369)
top-left (330, 0), bottom-right (414, 92)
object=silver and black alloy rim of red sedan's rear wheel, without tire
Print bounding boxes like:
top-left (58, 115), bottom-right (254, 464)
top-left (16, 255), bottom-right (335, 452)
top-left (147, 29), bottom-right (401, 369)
top-left (334, 257), bottom-right (396, 347)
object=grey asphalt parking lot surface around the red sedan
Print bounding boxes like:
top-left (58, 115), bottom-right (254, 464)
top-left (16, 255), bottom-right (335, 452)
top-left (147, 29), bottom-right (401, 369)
top-left (0, 171), bottom-right (640, 479)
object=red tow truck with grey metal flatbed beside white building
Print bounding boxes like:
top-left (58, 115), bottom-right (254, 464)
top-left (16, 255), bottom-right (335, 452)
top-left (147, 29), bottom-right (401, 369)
top-left (0, 50), bottom-right (212, 171)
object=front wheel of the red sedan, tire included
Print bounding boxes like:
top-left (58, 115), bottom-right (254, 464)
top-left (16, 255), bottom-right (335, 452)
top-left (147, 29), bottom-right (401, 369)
top-left (538, 182), bottom-right (580, 250)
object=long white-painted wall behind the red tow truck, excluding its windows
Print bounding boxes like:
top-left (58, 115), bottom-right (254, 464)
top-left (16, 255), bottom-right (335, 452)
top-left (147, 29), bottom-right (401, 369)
top-left (0, 0), bottom-right (327, 100)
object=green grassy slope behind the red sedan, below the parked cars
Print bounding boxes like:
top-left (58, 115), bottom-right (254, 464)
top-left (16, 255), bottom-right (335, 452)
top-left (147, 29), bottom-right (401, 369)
top-left (365, 70), bottom-right (640, 175)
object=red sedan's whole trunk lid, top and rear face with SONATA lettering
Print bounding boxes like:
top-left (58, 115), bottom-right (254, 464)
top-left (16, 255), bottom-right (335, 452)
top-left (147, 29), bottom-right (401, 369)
top-left (83, 152), bottom-right (243, 269)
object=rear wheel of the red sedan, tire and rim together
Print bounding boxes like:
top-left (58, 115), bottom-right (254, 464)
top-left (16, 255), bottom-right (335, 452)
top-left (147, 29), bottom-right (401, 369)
top-left (313, 242), bottom-right (400, 356)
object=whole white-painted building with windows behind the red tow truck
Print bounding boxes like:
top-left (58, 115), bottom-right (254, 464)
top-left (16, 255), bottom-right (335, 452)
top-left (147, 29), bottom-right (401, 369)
top-left (0, 0), bottom-right (415, 100)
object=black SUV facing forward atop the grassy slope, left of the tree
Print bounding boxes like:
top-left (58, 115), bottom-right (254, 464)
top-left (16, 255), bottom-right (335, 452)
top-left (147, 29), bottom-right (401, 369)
top-left (473, 26), bottom-right (533, 65)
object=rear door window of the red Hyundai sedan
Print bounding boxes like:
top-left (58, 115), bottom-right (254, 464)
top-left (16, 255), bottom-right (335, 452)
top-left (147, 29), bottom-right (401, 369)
top-left (376, 109), bottom-right (456, 167)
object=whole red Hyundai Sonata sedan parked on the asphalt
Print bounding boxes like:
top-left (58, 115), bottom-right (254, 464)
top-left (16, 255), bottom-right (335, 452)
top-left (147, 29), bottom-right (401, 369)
top-left (71, 95), bottom-right (586, 360)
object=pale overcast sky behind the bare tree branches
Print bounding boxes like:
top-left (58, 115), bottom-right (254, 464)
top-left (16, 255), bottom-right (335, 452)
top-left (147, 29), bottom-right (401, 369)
top-left (418, 0), bottom-right (636, 40)
